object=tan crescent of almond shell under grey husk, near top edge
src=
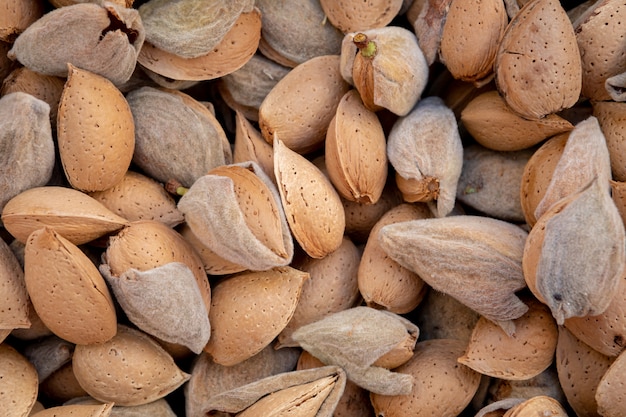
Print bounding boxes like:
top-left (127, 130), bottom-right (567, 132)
top-left (137, 9), bottom-right (261, 81)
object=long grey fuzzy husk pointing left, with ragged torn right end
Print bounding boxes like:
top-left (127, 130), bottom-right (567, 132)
top-left (379, 215), bottom-right (528, 334)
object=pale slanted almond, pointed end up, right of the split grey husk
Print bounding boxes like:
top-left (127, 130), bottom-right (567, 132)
top-left (274, 139), bottom-right (346, 258)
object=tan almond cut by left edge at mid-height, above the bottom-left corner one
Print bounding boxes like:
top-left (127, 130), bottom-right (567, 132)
top-left (0, 239), bottom-right (31, 330)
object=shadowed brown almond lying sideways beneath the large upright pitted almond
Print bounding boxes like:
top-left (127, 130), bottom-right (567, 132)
top-left (461, 91), bottom-right (574, 151)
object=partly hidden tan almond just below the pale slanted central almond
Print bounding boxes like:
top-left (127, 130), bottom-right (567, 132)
top-left (277, 237), bottom-right (360, 348)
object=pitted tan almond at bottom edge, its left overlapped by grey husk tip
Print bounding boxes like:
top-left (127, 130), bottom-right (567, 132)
top-left (370, 339), bottom-right (480, 417)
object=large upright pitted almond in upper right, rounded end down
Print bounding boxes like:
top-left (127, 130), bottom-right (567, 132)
top-left (495, 0), bottom-right (582, 120)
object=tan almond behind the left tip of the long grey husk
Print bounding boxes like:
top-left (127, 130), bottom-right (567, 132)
top-left (358, 203), bottom-right (432, 314)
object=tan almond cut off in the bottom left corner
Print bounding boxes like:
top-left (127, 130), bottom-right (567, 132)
top-left (0, 343), bottom-right (39, 417)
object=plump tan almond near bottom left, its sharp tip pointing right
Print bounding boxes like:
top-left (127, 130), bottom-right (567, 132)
top-left (72, 325), bottom-right (190, 406)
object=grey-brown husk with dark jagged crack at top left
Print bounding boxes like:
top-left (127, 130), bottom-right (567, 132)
top-left (9, 2), bottom-right (145, 85)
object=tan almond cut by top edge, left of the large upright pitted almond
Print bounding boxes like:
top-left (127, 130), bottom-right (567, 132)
top-left (439, 0), bottom-right (509, 87)
